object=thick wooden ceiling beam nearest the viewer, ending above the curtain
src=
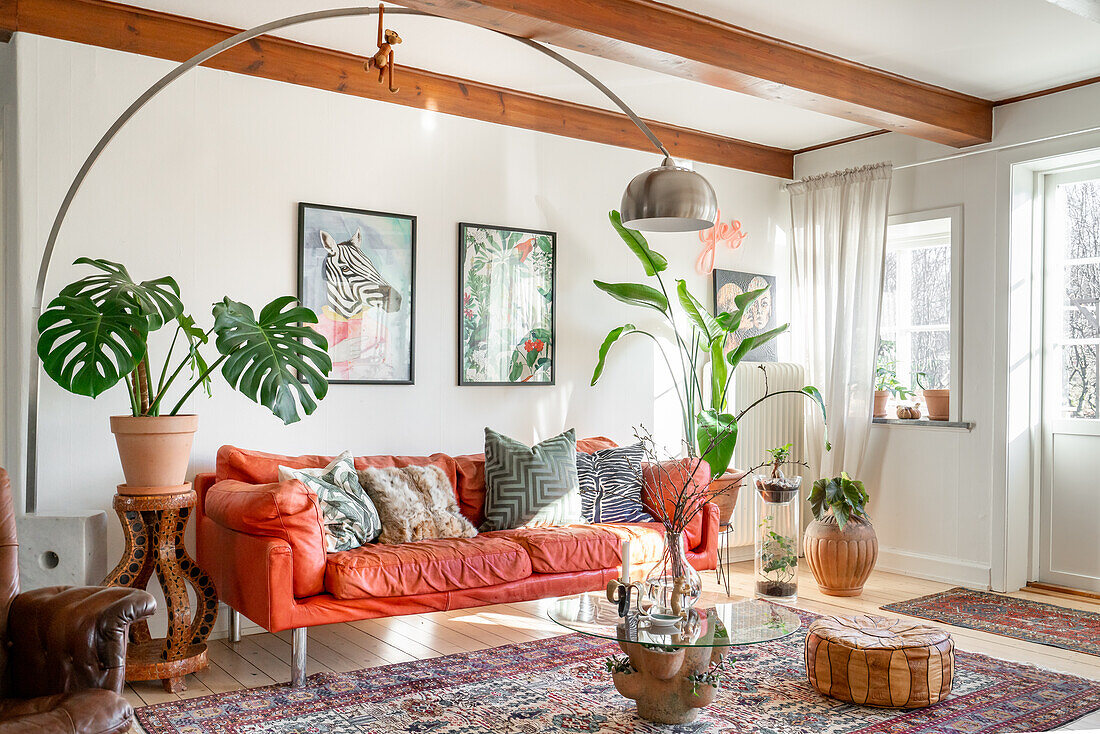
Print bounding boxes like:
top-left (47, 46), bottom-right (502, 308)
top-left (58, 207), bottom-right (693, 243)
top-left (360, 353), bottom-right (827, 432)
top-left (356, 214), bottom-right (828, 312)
top-left (391, 0), bottom-right (993, 146)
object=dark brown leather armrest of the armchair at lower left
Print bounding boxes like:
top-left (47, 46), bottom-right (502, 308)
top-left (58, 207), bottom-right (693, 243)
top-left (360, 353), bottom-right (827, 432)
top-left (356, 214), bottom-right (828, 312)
top-left (8, 587), bottom-right (156, 698)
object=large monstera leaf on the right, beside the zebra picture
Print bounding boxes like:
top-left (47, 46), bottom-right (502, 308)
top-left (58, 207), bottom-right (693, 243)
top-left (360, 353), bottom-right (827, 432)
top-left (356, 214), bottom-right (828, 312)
top-left (213, 296), bottom-right (332, 424)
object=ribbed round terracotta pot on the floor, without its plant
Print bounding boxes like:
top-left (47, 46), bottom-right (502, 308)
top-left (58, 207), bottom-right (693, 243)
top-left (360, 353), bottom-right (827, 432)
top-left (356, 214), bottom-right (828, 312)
top-left (803, 517), bottom-right (879, 596)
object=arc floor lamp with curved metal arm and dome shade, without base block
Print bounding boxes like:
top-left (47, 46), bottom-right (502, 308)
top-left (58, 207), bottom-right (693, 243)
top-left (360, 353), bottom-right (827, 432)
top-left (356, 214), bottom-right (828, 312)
top-left (25, 7), bottom-right (718, 514)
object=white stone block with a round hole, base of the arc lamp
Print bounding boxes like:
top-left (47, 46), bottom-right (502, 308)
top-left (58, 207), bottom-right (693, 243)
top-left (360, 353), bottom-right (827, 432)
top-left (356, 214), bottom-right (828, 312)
top-left (15, 512), bottom-right (108, 591)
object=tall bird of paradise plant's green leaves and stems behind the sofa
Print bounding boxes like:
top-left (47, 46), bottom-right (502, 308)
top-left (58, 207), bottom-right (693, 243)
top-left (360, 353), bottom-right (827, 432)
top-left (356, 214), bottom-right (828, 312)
top-left (592, 211), bottom-right (831, 478)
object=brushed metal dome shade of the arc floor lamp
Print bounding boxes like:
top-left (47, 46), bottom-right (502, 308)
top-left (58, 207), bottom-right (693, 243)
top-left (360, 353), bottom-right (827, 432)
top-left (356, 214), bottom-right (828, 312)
top-left (619, 156), bottom-right (718, 232)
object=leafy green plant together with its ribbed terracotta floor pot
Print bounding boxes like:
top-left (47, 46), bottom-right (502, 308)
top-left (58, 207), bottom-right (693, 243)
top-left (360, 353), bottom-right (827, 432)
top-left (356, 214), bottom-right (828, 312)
top-left (804, 473), bottom-right (879, 596)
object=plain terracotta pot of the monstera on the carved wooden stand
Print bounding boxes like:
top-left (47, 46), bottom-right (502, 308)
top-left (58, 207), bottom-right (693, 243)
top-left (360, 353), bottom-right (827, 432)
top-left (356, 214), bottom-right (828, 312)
top-left (111, 415), bottom-right (199, 494)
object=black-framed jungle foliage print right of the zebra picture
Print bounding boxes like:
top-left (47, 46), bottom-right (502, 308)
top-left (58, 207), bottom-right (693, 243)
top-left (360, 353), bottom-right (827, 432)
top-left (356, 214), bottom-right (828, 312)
top-left (459, 222), bottom-right (558, 385)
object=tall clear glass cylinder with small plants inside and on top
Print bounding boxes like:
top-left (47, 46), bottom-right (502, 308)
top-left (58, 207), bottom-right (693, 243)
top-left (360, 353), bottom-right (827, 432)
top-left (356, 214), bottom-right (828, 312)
top-left (752, 443), bottom-right (802, 602)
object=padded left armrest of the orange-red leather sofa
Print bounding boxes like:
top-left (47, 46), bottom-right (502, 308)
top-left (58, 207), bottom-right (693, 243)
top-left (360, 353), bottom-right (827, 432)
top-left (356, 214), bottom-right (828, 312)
top-left (206, 480), bottom-right (325, 599)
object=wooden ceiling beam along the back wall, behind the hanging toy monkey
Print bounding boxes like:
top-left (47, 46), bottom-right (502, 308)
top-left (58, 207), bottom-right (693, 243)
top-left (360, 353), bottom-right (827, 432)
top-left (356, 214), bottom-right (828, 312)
top-left (0, 0), bottom-right (794, 178)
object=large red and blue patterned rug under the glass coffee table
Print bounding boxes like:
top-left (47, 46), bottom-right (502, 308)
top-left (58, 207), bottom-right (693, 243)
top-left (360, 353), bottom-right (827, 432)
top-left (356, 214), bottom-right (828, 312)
top-left (138, 613), bottom-right (1100, 734)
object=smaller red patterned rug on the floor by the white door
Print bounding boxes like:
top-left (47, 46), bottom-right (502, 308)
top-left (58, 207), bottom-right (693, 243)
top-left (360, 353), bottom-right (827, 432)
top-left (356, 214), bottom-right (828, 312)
top-left (882, 588), bottom-right (1100, 655)
